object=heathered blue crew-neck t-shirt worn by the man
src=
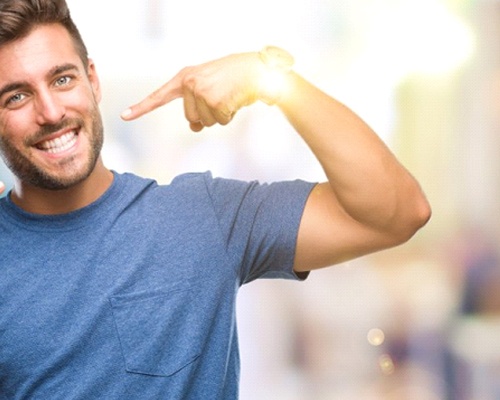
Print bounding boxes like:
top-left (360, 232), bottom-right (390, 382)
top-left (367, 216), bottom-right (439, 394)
top-left (0, 173), bottom-right (313, 400)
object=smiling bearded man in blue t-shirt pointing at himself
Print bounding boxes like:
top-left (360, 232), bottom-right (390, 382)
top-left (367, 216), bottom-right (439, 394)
top-left (0, 0), bottom-right (430, 400)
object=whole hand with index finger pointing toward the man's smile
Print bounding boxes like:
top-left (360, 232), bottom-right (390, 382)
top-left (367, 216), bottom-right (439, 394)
top-left (122, 53), bottom-right (265, 132)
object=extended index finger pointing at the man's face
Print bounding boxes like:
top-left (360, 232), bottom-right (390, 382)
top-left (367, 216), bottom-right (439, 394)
top-left (121, 76), bottom-right (182, 121)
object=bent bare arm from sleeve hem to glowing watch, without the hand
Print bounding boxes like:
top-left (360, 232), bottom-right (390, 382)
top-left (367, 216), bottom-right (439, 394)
top-left (278, 73), bottom-right (430, 271)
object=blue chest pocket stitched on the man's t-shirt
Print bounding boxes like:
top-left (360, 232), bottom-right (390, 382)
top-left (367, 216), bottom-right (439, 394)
top-left (110, 287), bottom-right (206, 376)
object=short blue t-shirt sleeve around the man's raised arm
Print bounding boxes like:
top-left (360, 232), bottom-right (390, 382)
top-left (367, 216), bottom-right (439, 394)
top-left (201, 174), bottom-right (314, 284)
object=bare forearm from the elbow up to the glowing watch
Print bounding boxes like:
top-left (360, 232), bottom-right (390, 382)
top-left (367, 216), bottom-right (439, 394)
top-left (278, 73), bottom-right (430, 236)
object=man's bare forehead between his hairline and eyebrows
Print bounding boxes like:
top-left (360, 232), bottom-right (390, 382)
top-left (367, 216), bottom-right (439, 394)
top-left (0, 24), bottom-right (83, 82)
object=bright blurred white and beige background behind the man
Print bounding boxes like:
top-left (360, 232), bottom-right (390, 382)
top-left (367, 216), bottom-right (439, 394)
top-left (0, 0), bottom-right (500, 400)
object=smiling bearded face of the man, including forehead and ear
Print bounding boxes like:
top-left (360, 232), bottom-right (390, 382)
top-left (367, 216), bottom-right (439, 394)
top-left (0, 24), bottom-right (103, 190)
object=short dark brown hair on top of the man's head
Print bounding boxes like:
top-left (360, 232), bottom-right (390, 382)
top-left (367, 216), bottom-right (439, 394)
top-left (0, 0), bottom-right (88, 66)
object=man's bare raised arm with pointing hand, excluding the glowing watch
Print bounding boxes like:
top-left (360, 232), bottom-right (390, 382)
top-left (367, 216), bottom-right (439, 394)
top-left (122, 47), bottom-right (430, 271)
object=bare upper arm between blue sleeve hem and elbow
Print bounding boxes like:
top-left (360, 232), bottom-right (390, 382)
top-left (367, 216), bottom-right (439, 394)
top-left (294, 183), bottom-right (398, 272)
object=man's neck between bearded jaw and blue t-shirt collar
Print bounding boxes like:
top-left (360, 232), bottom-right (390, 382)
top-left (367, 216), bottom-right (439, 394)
top-left (11, 159), bottom-right (113, 215)
